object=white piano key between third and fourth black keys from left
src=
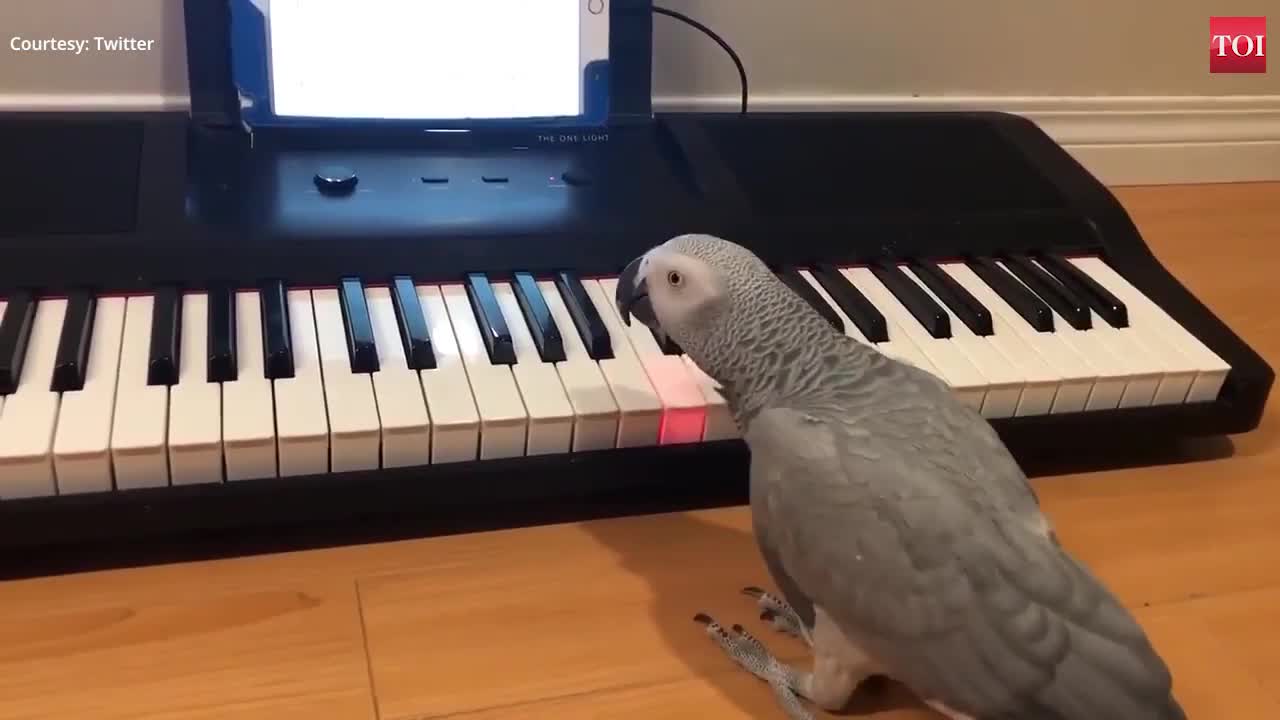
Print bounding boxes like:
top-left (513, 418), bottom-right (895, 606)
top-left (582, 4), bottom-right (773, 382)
top-left (168, 292), bottom-right (223, 486)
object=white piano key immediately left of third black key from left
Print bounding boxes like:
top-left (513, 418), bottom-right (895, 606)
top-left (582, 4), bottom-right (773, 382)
top-left (111, 295), bottom-right (169, 489)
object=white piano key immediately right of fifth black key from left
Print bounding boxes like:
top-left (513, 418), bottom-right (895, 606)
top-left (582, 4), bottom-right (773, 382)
top-left (271, 290), bottom-right (329, 478)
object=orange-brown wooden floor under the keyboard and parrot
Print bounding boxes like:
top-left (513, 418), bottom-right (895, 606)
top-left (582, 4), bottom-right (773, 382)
top-left (0, 184), bottom-right (1280, 720)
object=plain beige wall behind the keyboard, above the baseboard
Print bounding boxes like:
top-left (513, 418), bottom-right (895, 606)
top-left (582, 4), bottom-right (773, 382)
top-left (0, 0), bottom-right (1280, 101)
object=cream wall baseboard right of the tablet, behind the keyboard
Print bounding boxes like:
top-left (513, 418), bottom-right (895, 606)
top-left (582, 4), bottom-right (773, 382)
top-left (654, 95), bottom-right (1280, 186)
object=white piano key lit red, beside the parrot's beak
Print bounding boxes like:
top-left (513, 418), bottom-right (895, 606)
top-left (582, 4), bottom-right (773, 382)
top-left (599, 278), bottom-right (707, 445)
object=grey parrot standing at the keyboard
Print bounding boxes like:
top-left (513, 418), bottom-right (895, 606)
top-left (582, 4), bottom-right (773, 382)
top-left (614, 234), bottom-right (1185, 720)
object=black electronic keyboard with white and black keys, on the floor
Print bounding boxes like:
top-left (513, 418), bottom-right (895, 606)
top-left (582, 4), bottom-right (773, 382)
top-left (0, 107), bottom-right (1274, 576)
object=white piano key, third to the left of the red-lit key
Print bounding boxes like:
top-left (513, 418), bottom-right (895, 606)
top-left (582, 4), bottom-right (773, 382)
top-left (493, 282), bottom-right (575, 455)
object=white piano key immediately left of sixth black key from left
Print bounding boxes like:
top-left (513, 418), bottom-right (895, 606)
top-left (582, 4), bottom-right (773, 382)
top-left (311, 283), bottom-right (381, 473)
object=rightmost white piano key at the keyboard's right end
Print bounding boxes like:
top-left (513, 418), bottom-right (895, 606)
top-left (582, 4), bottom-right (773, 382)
top-left (1069, 258), bottom-right (1231, 405)
